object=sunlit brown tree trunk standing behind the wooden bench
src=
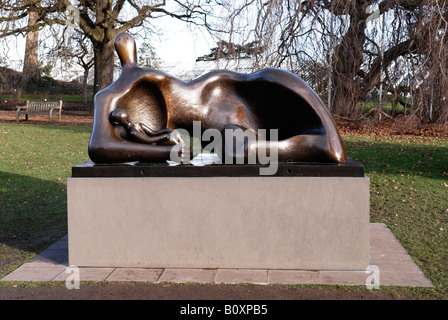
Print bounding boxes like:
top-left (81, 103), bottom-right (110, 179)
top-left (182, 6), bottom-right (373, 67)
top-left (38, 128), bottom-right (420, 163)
top-left (21, 12), bottom-right (40, 86)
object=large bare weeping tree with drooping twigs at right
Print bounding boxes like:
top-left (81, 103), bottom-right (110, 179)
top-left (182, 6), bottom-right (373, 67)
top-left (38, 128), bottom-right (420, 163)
top-left (222, 0), bottom-right (448, 121)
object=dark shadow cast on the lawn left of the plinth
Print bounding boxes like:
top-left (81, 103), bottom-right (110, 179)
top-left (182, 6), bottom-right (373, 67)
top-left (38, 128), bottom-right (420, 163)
top-left (0, 172), bottom-right (67, 275)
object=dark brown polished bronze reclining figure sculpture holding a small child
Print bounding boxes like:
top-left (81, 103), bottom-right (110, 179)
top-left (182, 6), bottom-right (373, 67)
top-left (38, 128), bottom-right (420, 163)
top-left (89, 33), bottom-right (347, 163)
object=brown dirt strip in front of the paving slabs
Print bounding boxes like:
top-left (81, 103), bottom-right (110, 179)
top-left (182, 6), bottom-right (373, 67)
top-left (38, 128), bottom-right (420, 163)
top-left (0, 282), bottom-right (410, 300)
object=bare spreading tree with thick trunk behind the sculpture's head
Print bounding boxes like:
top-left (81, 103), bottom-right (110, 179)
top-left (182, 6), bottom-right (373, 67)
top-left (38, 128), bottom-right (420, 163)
top-left (0, 0), bottom-right (217, 94)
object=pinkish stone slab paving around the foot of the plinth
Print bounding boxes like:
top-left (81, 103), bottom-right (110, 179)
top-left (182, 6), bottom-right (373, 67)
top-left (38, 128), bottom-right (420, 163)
top-left (0, 223), bottom-right (433, 287)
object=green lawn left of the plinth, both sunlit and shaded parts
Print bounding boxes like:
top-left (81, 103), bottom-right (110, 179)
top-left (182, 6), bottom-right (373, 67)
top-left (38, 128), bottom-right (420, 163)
top-left (0, 124), bottom-right (91, 276)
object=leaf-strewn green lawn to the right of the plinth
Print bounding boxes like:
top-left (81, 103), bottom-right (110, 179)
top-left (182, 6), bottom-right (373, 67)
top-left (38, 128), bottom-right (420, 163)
top-left (345, 137), bottom-right (448, 298)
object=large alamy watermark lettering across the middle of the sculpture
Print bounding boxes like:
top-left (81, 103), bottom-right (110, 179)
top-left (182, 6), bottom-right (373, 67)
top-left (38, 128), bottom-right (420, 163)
top-left (170, 121), bottom-right (278, 175)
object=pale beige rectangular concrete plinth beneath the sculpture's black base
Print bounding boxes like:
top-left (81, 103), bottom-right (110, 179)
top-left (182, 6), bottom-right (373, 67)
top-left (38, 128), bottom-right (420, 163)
top-left (68, 160), bottom-right (370, 270)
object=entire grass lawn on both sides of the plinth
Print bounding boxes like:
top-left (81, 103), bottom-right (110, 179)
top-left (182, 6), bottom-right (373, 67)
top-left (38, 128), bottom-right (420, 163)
top-left (0, 124), bottom-right (448, 299)
